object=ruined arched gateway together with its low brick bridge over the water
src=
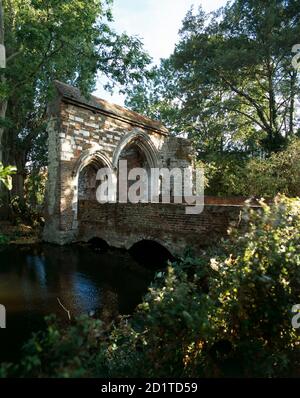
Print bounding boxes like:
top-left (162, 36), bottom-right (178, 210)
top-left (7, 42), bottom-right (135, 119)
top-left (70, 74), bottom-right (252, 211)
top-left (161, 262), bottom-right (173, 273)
top-left (44, 82), bottom-right (241, 255)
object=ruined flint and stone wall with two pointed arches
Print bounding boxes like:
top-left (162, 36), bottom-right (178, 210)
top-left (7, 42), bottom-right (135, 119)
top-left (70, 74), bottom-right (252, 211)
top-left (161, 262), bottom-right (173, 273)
top-left (44, 82), bottom-right (193, 244)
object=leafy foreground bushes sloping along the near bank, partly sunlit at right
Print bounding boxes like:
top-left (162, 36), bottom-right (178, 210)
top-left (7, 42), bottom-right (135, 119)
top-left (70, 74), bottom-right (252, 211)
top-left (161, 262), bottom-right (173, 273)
top-left (0, 196), bottom-right (300, 377)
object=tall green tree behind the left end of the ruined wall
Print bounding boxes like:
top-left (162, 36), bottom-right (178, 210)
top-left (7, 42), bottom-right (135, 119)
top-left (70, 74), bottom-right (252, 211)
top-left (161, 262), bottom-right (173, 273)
top-left (0, 0), bottom-right (150, 204)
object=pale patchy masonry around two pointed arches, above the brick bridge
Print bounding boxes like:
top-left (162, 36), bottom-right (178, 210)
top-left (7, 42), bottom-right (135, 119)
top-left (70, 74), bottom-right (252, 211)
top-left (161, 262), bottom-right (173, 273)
top-left (44, 84), bottom-right (193, 244)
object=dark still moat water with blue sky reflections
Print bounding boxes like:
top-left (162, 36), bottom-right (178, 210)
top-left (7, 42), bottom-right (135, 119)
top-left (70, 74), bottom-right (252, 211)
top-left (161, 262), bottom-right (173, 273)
top-left (0, 244), bottom-right (153, 362)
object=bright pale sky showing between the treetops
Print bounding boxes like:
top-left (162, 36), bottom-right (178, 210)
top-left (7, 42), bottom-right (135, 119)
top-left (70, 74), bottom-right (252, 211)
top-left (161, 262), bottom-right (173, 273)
top-left (94, 0), bottom-right (227, 105)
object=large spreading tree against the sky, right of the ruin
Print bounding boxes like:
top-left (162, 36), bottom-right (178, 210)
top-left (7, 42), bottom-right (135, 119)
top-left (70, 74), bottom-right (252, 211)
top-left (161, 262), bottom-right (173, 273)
top-left (128, 0), bottom-right (300, 155)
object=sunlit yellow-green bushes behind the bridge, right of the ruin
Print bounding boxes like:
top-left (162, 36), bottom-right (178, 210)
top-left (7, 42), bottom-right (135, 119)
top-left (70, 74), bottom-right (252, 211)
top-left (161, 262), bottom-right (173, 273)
top-left (199, 139), bottom-right (300, 198)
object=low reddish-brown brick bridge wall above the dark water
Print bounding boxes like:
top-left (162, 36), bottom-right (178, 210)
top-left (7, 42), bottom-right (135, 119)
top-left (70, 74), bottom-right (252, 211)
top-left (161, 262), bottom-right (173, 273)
top-left (79, 201), bottom-right (241, 256)
